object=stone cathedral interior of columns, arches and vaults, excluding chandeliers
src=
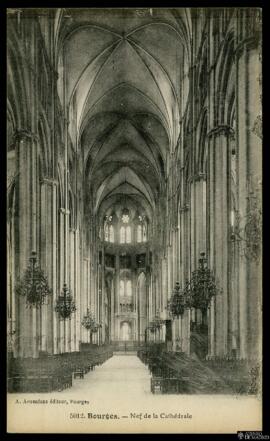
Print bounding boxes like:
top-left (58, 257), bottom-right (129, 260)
top-left (7, 8), bottom-right (262, 384)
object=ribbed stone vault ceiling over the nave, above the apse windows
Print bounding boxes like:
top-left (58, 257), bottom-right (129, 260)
top-left (61, 9), bottom-right (188, 223)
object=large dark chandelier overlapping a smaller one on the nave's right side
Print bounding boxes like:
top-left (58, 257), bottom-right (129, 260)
top-left (185, 253), bottom-right (217, 311)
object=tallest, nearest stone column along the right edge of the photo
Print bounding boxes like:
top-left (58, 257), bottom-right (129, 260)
top-left (236, 9), bottom-right (262, 358)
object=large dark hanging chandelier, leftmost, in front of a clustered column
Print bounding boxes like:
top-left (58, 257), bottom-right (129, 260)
top-left (16, 251), bottom-right (52, 308)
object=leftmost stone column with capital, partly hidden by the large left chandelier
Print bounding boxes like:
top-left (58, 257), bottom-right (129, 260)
top-left (15, 130), bottom-right (39, 357)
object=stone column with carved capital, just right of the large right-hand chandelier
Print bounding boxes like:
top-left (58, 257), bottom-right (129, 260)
top-left (208, 126), bottom-right (231, 357)
